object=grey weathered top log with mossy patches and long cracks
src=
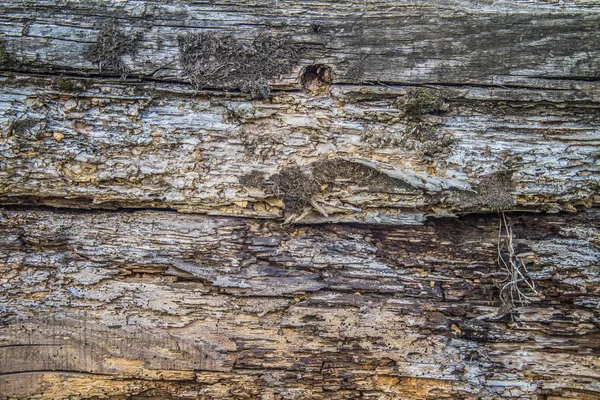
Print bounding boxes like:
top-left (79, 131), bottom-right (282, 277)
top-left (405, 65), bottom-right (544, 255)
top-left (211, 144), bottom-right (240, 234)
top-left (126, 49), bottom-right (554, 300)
top-left (0, 0), bottom-right (600, 88)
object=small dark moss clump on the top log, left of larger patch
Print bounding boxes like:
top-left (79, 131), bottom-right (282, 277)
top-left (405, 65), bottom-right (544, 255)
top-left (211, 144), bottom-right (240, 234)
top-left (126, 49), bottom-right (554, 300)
top-left (86, 21), bottom-right (142, 77)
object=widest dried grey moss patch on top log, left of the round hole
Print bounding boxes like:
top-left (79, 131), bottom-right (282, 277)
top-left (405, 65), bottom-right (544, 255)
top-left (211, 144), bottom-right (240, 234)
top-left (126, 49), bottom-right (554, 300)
top-left (177, 32), bottom-right (300, 98)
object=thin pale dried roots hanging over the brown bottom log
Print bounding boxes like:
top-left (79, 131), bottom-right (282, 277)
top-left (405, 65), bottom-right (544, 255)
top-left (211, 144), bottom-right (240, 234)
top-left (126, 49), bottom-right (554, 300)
top-left (498, 212), bottom-right (540, 309)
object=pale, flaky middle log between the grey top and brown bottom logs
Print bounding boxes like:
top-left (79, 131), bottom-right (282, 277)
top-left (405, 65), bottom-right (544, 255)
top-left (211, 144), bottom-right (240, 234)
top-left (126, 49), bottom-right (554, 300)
top-left (0, 76), bottom-right (600, 223)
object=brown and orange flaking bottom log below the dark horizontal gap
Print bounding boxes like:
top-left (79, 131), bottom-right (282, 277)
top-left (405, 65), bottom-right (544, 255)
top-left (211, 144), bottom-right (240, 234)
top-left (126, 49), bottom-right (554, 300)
top-left (0, 209), bottom-right (600, 399)
